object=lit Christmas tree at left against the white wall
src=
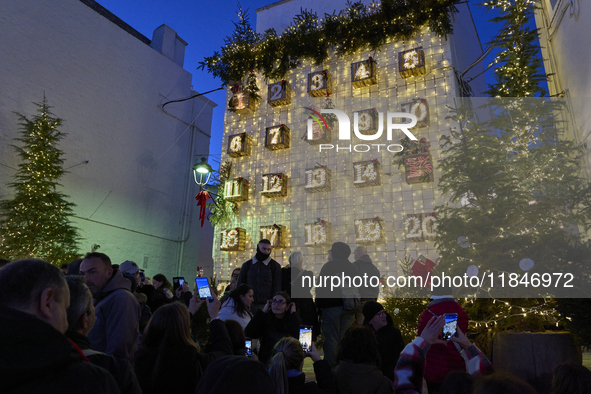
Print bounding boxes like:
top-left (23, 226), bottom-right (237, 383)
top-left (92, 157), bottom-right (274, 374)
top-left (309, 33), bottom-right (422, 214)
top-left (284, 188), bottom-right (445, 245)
top-left (0, 97), bottom-right (79, 266)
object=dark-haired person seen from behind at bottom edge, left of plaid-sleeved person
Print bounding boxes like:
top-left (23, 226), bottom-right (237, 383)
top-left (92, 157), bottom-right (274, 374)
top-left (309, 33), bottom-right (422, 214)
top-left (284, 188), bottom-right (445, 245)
top-left (334, 325), bottom-right (392, 394)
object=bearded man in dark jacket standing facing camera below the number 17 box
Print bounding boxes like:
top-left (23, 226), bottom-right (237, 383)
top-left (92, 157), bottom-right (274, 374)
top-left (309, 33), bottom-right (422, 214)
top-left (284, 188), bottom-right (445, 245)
top-left (238, 239), bottom-right (281, 312)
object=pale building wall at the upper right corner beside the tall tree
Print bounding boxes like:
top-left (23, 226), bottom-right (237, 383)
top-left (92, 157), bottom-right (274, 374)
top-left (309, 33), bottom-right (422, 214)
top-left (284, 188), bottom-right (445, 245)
top-left (536, 0), bottom-right (591, 180)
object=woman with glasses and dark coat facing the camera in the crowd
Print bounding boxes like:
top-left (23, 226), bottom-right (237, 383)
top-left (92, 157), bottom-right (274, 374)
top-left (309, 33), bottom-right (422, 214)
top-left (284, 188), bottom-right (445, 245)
top-left (244, 291), bottom-right (302, 363)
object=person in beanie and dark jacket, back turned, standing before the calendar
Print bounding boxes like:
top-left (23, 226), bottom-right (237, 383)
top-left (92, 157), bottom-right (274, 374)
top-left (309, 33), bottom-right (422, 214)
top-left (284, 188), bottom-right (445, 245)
top-left (316, 242), bottom-right (359, 368)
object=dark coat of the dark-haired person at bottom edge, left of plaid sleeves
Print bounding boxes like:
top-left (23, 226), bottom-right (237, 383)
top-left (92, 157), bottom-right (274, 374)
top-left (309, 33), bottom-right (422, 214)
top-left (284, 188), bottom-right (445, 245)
top-left (334, 360), bottom-right (392, 394)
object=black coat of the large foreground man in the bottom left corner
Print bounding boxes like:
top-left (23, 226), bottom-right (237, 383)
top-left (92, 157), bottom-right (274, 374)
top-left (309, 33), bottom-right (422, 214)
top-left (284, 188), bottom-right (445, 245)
top-left (0, 308), bottom-right (119, 394)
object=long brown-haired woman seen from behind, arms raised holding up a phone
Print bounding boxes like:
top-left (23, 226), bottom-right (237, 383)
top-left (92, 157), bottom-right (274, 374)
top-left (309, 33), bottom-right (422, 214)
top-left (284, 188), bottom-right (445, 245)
top-left (134, 294), bottom-right (232, 394)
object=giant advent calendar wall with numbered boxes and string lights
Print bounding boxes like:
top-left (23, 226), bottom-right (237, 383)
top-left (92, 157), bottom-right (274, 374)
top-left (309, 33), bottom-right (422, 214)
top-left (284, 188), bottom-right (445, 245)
top-left (213, 21), bottom-right (457, 284)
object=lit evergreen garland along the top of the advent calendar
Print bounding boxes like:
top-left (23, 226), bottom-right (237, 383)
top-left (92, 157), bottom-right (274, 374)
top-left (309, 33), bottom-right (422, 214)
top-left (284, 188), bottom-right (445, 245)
top-left (199, 0), bottom-right (461, 84)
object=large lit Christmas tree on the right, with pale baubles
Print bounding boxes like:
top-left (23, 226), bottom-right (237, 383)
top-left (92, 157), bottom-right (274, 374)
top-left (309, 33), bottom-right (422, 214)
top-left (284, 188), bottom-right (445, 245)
top-left (436, 0), bottom-right (591, 348)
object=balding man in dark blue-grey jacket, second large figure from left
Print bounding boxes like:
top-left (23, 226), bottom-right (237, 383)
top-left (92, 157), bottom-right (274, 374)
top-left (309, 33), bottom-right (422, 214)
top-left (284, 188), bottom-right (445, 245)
top-left (80, 252), bottom-right (141, 361)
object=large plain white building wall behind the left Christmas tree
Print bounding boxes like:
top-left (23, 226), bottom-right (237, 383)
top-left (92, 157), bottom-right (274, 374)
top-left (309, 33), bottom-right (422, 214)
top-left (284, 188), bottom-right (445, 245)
top-left (0, 0), bottom-right (215, 278)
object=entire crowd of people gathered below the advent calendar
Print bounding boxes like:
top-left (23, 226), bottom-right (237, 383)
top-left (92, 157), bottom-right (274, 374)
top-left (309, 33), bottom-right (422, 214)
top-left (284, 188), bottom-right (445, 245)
top-left (0, 240), bottom-right (591, 394)
